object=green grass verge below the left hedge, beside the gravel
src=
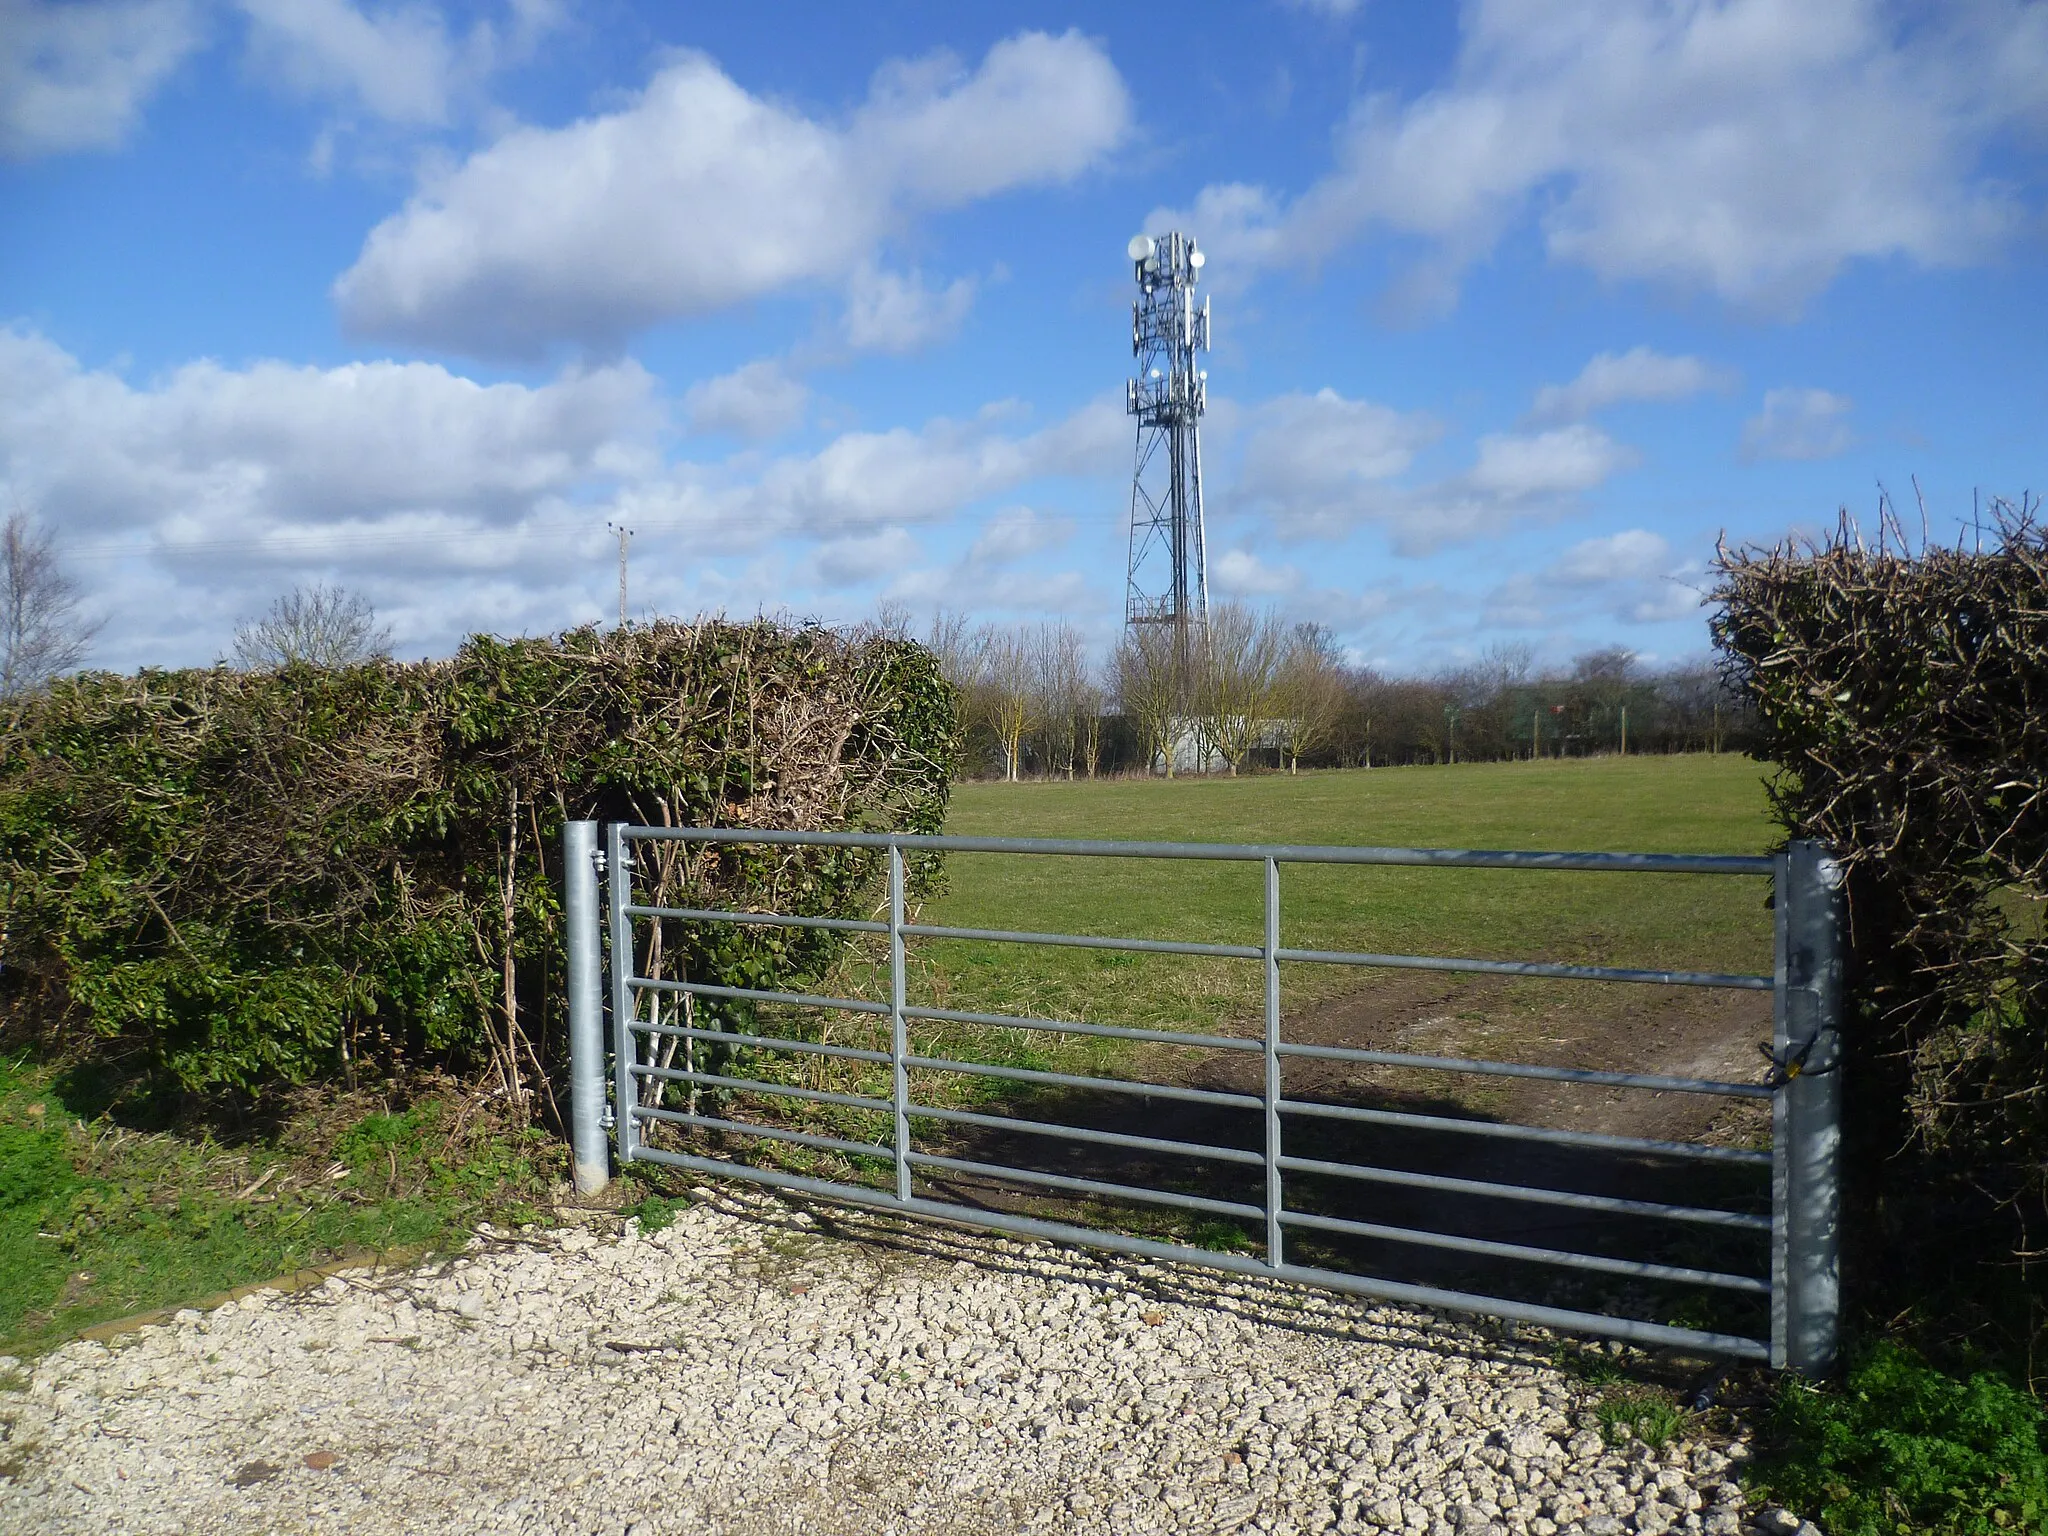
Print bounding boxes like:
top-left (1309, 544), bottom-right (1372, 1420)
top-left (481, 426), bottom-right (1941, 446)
top-left (0, 1063), bottom-right (549, 1356)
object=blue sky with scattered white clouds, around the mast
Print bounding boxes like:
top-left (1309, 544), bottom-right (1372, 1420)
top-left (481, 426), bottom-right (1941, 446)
top-left (0, 0), bottom-right (2048, 672)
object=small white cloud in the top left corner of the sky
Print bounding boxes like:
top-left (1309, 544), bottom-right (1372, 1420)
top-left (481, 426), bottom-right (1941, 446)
top-left (0, 0), bottom-right (201, 160)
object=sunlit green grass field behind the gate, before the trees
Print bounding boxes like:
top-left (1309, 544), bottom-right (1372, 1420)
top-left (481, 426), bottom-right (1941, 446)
top-left (888, 756), bottom-right (1774, 1028)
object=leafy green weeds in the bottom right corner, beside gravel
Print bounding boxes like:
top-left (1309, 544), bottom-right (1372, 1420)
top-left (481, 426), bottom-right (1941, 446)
top-left (1753, 1341), bottom-right (2048, 1536)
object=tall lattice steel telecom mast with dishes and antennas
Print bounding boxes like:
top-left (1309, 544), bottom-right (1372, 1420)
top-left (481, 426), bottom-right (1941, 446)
top-left (1124, 231), bottom-right (1208, 680)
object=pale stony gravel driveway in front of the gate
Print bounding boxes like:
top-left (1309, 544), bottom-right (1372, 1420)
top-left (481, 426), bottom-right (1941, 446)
top-left (0, 1192), bottom-right (1819, 1536)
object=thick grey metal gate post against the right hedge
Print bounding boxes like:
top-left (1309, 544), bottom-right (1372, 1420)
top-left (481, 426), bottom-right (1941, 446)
top-left (1772, 838), bottom-right (1847, 1376)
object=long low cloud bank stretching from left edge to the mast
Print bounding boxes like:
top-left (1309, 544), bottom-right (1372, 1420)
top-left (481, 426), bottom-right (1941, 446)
top-left (0, 328), bottom-right (1128, 666)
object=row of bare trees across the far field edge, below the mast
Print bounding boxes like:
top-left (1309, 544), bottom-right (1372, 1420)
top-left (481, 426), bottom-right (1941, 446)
top-left (921, 604), bottom-right (1753, 778)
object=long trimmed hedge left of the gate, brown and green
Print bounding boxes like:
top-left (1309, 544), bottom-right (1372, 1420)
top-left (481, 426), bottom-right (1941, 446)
top-left (0, 621), bottom-right (956, 1100)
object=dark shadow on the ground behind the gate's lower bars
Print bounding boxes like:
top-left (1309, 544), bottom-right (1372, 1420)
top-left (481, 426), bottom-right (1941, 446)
top-left (671, 1083), bottom-right (1769, 1337)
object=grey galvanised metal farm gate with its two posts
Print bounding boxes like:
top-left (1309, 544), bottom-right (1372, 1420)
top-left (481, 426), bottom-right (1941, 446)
top-left (565, 821), bottom-right (1843, 1372)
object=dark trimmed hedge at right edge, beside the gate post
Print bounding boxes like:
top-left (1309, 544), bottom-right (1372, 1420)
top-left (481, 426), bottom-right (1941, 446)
top-left (1714, 504), bottom-right (2048, 1290)
